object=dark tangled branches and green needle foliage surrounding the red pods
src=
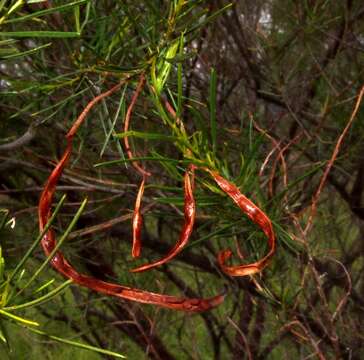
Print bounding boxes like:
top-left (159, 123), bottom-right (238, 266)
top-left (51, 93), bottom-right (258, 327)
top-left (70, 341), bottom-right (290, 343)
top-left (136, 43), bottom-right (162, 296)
top-left (0, 0), bottom-right (364, 359)
